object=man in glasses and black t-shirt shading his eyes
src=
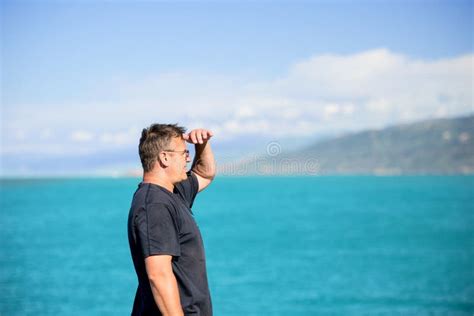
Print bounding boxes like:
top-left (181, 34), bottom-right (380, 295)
top-left (128, 124), bottom-right (215, 316)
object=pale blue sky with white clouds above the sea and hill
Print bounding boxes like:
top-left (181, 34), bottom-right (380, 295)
top-left (1, 1), bottom-right (473, 174)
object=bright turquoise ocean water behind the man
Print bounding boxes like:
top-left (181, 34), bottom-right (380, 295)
top-left (0, 176), bottom-right (474, 316)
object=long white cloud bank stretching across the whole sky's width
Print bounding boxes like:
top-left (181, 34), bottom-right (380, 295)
top-left (2, 49), bottom-right (474, 156)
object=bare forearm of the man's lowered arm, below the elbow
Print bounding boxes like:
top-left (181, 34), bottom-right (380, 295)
top-left (150, 273), bottom-right (184, 316)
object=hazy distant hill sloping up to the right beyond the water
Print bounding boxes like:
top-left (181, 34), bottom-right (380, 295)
top-left (219, 115), bottom-right (474, 175)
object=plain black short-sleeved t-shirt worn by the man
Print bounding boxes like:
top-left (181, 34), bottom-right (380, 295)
top-left (128, 171), bottom-right (212, 316)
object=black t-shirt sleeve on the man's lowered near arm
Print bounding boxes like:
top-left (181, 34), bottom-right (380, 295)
top-left (136, 204), bottom-right (181, 258)
